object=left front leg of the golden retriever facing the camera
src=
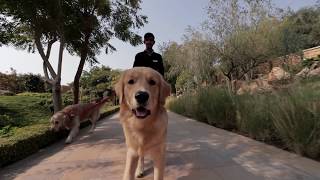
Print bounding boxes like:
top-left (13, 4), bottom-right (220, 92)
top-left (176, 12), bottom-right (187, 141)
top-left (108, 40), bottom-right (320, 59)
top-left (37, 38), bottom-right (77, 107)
top-left (123, 148), bottom-right (139, 180)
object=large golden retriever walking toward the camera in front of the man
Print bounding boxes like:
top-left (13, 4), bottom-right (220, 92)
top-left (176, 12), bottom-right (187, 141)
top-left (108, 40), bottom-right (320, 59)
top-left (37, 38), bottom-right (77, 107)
top-left (115, 67), bottom-right (171, 180)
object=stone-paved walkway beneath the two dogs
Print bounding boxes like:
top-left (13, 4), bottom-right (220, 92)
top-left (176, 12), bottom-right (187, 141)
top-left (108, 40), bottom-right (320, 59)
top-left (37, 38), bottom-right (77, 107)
top-left (0, 112), bottom-right (320, 180)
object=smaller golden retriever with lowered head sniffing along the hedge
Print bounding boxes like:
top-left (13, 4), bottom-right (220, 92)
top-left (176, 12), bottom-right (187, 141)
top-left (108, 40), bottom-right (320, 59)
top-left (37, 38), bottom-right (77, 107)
top-left (50, 98), bottom-right (109, 143)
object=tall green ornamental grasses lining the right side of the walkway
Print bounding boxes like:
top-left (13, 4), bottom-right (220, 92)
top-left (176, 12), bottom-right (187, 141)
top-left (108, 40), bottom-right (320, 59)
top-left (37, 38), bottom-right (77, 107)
top-left (168, 78), bottom-right (320, 159)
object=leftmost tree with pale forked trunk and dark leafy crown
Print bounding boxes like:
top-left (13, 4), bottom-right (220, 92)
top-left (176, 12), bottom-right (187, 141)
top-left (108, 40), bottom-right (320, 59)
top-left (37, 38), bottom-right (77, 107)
top-left (0, 0), bottom-right (65, 112)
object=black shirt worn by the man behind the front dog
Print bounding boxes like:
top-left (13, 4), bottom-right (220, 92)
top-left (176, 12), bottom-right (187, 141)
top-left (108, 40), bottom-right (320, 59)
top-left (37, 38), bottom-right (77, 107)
top-left (133, 51), bottom-right (164, 76)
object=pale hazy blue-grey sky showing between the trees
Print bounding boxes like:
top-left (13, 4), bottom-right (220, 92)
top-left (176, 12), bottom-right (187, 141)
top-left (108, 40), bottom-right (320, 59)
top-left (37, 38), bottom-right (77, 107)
top-left (0, 0), bottom-right (316, 84)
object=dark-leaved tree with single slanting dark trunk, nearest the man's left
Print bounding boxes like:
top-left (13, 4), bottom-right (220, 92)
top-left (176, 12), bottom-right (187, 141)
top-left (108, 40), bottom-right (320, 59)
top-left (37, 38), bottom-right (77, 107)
top-left (67, 0), bottom-right (146, 104)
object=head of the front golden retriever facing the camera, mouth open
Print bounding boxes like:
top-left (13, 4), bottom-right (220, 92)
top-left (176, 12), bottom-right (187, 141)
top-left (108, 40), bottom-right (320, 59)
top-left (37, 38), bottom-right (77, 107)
top-left (115, 67), bottom-right (170, 119)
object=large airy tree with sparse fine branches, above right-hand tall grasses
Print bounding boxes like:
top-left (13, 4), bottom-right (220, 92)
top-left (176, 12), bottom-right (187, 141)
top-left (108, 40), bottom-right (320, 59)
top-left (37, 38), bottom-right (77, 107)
top-left (204, 0), bottom-right (290, 82)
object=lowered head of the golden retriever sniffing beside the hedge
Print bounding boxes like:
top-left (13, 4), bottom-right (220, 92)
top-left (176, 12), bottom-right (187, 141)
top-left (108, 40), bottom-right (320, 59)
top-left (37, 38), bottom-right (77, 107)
top-left (50, 111), bottom-right (72, 131)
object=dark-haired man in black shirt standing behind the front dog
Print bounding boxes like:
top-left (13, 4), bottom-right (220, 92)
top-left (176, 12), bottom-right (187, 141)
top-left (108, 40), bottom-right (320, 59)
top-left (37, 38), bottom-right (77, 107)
top-left (133, 32), bottom-right (164, 76)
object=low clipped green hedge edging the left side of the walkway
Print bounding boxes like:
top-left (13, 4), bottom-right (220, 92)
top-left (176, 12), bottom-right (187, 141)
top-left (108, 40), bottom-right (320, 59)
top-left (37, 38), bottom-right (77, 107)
top-left (0, 107), bottom-right (119, 167)
